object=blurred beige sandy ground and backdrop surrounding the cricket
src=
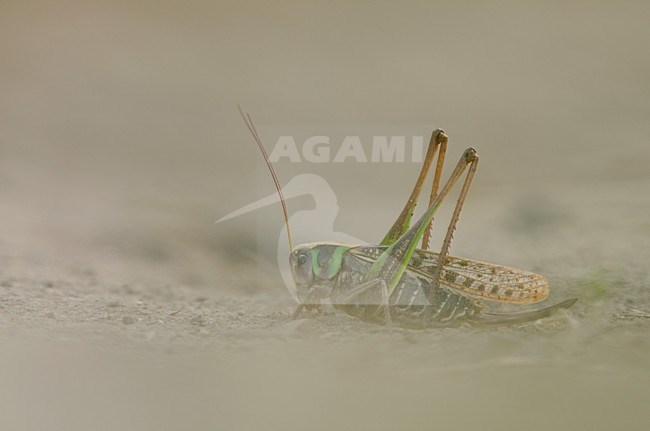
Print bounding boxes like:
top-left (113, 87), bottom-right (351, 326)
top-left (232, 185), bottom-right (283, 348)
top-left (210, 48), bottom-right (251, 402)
top-left (0, 0), bottom-right (650, 430)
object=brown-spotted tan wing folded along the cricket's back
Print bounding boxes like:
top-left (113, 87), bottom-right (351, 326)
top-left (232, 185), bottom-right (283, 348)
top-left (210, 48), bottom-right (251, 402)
top-left (350, 246), bottom-right (549, 304)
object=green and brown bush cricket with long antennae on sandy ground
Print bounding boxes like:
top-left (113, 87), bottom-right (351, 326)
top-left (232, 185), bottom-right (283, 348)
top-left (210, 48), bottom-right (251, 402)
top-left (230, 112), bottom-right (577, 328)
